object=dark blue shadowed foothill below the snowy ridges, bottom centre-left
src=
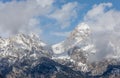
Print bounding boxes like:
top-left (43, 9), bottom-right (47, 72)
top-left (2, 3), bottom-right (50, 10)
top-left (3, 57), bottom-right (85, 78)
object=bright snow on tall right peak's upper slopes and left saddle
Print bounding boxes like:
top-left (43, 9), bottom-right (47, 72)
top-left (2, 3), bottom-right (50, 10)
top-left (52, 23), bottom-right (95, 55)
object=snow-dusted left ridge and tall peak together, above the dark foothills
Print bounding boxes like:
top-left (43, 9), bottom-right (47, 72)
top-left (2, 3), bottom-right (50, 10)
top-left (0, 23), bottom-right (96, 71)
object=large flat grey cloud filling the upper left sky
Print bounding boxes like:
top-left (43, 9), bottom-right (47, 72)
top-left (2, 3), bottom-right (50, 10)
top-left (0, 0), bottom-right (54, 37)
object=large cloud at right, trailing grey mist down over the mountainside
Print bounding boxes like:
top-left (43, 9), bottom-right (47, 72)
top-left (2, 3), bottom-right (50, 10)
top-left (84, 3), bottom-right (120, 59)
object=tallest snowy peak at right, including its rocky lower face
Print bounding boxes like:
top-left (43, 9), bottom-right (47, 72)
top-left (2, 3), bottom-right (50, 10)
top-left (52, 23), bottom-right (96, 71)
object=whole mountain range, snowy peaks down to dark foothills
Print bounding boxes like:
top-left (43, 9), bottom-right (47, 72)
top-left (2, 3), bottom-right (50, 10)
top-left (0, 23), bottom-right (120, 78)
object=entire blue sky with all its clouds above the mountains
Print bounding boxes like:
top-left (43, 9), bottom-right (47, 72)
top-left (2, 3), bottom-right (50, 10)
top-left (0, 0), bottom-right (120, 46)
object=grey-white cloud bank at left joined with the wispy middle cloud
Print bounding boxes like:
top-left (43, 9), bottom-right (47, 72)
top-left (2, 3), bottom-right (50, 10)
top-left (0, 0), bottom-right (77, 37)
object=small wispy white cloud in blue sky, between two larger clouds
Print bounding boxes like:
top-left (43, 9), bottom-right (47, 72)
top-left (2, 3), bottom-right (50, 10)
top-left (50, 2), bottom-right (78, 28)
